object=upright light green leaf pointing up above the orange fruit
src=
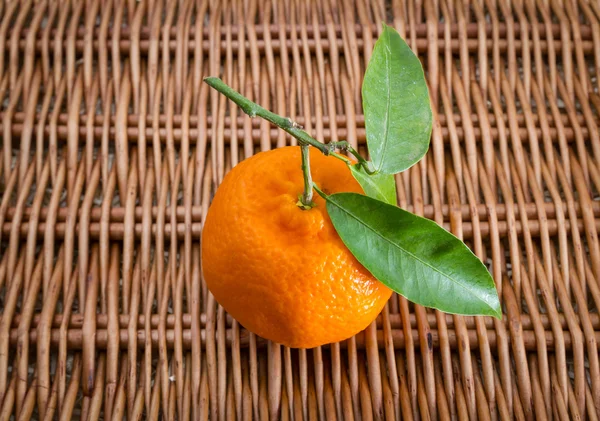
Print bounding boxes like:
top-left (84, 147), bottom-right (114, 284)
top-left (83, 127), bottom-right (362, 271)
top-left (362, 24), bottom-right (432, 174)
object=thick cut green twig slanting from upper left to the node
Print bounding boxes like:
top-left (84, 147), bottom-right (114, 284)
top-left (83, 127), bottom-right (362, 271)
top-left (204, 77), bottom-right (329, 155)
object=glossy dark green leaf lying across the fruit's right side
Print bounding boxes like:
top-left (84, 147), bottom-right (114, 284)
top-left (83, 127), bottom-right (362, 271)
top-left (326, 193), bottom-right (502, 318)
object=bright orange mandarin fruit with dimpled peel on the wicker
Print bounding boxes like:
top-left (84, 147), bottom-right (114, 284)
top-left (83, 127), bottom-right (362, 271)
top-left (202, 146), bottom-right (391, 348)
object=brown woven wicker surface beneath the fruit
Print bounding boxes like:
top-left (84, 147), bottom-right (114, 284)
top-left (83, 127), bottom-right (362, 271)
top-left (0, 0), bottom-right (600, 420)
